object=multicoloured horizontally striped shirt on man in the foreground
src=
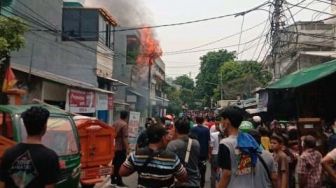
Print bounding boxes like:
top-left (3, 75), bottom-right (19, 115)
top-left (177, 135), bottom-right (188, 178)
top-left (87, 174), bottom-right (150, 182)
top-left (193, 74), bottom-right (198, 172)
top-left (123, 147), bottom-right (186, 188)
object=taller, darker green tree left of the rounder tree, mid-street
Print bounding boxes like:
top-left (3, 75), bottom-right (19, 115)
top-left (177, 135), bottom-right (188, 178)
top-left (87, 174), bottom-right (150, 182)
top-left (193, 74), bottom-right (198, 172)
top-left (195, 50), bottom-right (235, 106)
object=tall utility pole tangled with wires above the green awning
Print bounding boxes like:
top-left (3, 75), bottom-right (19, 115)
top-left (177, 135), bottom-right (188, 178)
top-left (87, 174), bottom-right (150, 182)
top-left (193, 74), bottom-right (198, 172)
top-left (271, 0), bottom-right (284, 79)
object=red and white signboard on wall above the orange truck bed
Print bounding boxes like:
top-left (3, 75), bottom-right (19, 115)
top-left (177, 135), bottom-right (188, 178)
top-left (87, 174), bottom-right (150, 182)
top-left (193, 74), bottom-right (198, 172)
top-left (66, 89), bottom-right (96, 113)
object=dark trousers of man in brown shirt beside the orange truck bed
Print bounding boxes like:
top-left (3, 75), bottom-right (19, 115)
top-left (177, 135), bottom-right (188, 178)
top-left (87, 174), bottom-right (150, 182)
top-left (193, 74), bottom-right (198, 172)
top-left (111, 150), bottom-right (126, 185)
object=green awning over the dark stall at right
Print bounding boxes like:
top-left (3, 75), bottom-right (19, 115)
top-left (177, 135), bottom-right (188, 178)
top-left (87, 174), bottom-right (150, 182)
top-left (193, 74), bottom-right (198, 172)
top-left (267, 60), bottom-right (336, 89)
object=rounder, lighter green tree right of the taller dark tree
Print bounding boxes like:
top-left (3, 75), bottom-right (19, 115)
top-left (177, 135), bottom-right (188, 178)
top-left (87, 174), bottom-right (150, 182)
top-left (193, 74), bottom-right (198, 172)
top-left (215, 61), bottom-right (272, 99)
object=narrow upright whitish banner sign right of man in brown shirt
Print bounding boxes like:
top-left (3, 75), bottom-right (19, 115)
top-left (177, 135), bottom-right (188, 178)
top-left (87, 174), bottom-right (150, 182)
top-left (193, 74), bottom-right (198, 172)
top-left (128, 111), bottom-right (140, 150)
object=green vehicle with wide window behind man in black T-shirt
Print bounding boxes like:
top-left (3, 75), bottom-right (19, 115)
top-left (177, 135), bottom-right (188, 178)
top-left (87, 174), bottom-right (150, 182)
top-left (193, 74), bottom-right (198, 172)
top-left (0, 104), bottom-right (81, 188)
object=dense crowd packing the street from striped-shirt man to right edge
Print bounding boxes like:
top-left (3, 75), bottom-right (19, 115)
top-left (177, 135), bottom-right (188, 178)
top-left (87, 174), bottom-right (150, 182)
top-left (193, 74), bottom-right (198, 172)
top-left (112, 107), bottom-right (336, 188)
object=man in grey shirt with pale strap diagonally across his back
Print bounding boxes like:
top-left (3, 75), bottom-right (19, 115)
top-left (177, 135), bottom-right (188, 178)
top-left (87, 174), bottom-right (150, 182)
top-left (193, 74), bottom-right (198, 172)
top-left (166, 118), bottom-right (201, 188)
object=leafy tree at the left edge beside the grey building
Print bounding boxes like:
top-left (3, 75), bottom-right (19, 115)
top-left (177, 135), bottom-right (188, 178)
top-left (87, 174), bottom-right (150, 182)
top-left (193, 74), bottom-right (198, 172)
top-left (0, 16), bottom-right (27, 103)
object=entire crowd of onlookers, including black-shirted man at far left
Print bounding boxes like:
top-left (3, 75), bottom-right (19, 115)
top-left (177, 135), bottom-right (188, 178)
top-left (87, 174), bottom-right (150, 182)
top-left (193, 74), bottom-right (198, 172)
top-left (0, 107), bottom-right (336, 188)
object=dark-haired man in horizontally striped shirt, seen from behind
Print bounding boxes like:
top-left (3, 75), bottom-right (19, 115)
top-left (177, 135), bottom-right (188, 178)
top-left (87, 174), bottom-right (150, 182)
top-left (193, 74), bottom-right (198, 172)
top-left (119, 125), bottom-right (187, 188)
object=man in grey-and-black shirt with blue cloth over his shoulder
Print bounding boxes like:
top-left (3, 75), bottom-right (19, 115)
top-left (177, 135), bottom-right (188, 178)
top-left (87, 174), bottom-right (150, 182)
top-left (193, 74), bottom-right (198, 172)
top-left (217, 107), bottom-right (276, 188)
